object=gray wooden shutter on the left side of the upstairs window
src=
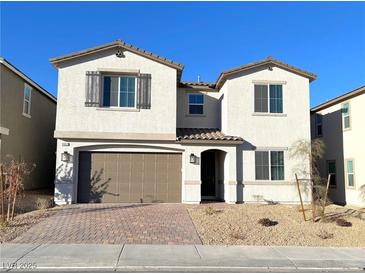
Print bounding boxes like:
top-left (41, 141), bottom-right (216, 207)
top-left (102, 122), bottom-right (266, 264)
top-left (85, 71), bottom-right (101, 107)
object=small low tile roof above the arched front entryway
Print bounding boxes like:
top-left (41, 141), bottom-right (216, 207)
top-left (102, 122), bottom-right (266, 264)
top-left (176, 128), bottom-right (243, 143)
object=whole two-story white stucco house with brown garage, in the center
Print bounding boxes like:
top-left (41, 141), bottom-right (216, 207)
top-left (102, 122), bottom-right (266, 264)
top-left (51, 40), bottom-right (316, 204)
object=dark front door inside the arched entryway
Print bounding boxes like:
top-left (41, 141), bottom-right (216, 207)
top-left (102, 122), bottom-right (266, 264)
top-left (200, 151), bottom-right (215, 198)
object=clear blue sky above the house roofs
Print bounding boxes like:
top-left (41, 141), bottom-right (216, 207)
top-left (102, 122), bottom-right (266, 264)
top-left (0, 2), bottom-right (365, 106)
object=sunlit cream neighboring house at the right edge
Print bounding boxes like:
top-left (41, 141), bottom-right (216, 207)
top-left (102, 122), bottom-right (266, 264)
top-left (311, 86), bottom-right (365, 206)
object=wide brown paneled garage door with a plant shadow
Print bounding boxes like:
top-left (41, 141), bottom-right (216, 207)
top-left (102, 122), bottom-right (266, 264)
top-left (77, 152), bottom-right (181, 203)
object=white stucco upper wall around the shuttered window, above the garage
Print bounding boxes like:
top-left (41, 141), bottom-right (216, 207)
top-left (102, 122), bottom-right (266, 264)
top-left (56, 50), bottom-right (177, 139)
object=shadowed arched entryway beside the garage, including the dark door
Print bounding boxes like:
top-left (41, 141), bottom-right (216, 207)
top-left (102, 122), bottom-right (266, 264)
top-left (200, 149), bottom-right (226, 201)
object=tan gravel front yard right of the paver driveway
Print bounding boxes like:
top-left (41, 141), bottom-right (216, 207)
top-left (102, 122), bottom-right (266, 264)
top-left (188, 204), bottom-right (365, 247)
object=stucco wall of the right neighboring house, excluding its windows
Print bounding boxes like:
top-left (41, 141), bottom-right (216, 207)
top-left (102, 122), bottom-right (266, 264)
top-left (312, 94), bottom-right (365, 206)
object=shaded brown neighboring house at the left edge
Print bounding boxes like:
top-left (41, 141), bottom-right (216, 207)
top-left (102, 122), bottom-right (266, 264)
top-left (0, 57), bottom-right (57, 190)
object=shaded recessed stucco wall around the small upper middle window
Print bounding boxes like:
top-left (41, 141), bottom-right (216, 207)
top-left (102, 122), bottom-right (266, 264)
top-left (177, 89), bottom-right (221, 128)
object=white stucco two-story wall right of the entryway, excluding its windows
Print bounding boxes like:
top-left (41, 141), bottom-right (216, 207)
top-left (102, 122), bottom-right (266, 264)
top-left (221, 67), bottom-right (310, 202)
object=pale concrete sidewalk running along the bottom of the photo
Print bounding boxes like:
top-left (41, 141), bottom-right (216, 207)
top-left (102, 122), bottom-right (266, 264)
top-left (0, 244), bottom-right (365, 272)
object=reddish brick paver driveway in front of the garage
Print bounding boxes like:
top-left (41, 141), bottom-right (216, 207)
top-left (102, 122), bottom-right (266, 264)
top-left (12, 204), bottom-right (201, 244)
